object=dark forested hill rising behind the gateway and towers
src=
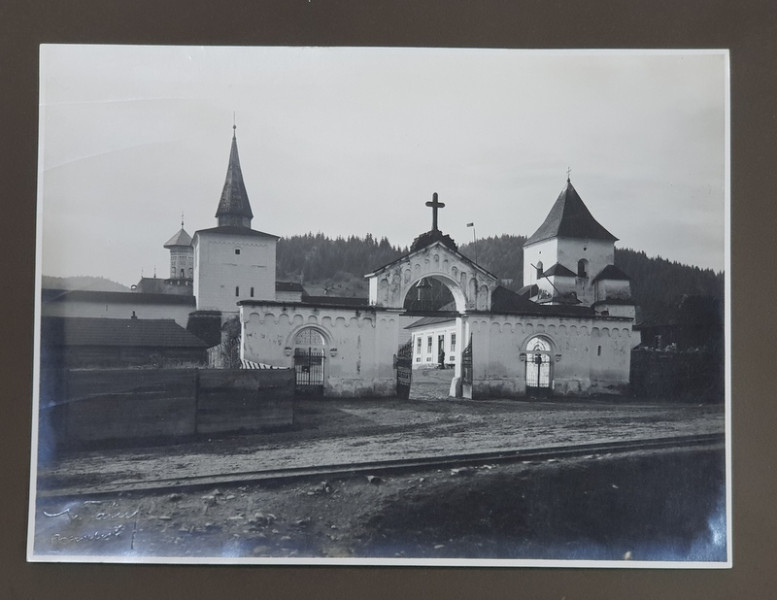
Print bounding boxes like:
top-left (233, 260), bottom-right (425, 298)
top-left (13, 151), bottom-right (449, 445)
top-left (277, 233), bottom-right (724, 324)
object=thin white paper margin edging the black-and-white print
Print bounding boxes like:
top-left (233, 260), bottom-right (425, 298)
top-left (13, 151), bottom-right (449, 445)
top-left (27, 45), bottom-right (732, 569)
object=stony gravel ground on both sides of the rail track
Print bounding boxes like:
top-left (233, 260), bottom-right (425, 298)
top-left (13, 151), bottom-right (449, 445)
top-left (34, 399), bottom-right (725, 561)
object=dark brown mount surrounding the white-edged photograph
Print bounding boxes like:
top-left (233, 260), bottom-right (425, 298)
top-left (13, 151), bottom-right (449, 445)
top-left (0, 0), bottom-right (777, 598)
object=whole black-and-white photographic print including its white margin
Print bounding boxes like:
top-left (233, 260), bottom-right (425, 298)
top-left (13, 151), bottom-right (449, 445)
top-left (27, 44), bottom-right (732, 569)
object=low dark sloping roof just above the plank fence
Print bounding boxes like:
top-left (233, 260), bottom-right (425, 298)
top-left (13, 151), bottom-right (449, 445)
top-left (41, 317), bottom-right (207, 348)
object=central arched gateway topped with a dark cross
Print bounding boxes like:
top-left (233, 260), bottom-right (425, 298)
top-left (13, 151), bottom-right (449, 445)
top-left (365, 193), bottom-right (499, 397)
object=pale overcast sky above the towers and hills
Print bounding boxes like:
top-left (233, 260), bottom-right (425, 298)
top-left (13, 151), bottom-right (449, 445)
top-left (39, 46), bottom-right (728, 285)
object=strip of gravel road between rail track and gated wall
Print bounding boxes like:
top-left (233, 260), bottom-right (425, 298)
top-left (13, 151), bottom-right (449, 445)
top-left (38, 392), bottom-right (724, 493)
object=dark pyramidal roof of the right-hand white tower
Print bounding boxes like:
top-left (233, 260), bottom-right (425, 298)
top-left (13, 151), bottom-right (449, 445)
top-left (524, 179), bottom-right (618, 246)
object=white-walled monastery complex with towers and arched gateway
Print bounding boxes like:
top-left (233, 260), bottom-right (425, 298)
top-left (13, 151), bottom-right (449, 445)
top-left (43, 127), bottom-right (639, 398)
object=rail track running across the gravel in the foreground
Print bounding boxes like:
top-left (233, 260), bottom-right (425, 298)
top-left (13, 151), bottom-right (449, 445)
top-left (37, 433), bottom-right (725, 499)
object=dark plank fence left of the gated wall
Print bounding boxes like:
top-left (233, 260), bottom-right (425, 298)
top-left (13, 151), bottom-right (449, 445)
top-left (39, 369), bottom-right (294, 445)
